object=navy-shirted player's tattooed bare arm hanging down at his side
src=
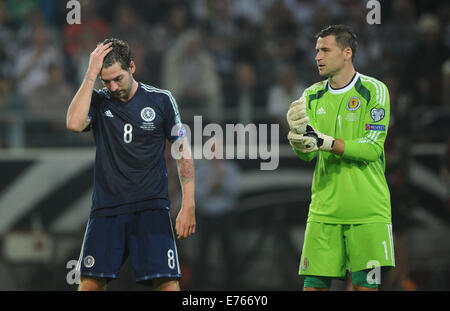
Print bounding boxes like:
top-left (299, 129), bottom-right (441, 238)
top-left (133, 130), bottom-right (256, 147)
top-left (175, 137), bottom-right (196, 239)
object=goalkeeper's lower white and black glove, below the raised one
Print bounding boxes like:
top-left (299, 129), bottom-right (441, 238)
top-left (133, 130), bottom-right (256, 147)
top-left (288, 125), bottom-right (334, 153)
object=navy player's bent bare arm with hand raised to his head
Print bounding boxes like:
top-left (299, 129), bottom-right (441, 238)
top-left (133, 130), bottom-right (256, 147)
top-left (66, 42), bottom-right (112, 132)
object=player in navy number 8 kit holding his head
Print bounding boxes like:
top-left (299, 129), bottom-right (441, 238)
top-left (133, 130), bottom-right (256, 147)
top-left (66, 39), bottom-right (196, 290)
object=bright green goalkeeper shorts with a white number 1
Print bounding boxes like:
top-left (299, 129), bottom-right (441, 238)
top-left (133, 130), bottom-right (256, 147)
top-left (299, 222), bottom-right (395, 278)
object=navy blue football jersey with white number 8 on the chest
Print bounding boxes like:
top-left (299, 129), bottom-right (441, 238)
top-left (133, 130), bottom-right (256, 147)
top-left (86, 83), bottom-right (185, 217)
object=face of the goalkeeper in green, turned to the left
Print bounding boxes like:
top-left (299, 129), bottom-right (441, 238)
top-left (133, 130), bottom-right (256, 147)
top-left (315, 35), bottom-right (351, 77)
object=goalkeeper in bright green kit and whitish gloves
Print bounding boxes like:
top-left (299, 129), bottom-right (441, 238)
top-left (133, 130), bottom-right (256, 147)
top-left (287, 25), bottom-right (395, 290)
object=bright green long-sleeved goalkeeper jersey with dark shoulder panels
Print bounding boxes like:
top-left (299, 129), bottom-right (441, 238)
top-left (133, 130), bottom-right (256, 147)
top-left (295, 73), bottom-right (391, 224)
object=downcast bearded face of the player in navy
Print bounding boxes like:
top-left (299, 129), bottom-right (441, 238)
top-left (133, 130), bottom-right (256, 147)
top-left (100, 62), bottom-right (135, 101)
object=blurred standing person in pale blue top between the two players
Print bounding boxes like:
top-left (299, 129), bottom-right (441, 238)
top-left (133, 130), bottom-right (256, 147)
top-left (193, 138), bottom-right (241, 290)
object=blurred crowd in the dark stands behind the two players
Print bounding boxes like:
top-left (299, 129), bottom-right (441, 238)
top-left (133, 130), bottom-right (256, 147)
top-left (0, 0), bottom-right (450, 288)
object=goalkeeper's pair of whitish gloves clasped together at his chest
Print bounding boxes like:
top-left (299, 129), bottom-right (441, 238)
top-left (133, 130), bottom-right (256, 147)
top-left (287, 96), bottom-right (335, 153)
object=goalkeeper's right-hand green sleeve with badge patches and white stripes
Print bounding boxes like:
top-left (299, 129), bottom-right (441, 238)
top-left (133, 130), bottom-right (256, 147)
top-left (342, 84), bottom-right (390, 162)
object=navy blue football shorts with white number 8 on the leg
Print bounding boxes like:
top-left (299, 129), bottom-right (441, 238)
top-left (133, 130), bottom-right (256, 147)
top-left (78, 210), bottom-right (181, 282)
